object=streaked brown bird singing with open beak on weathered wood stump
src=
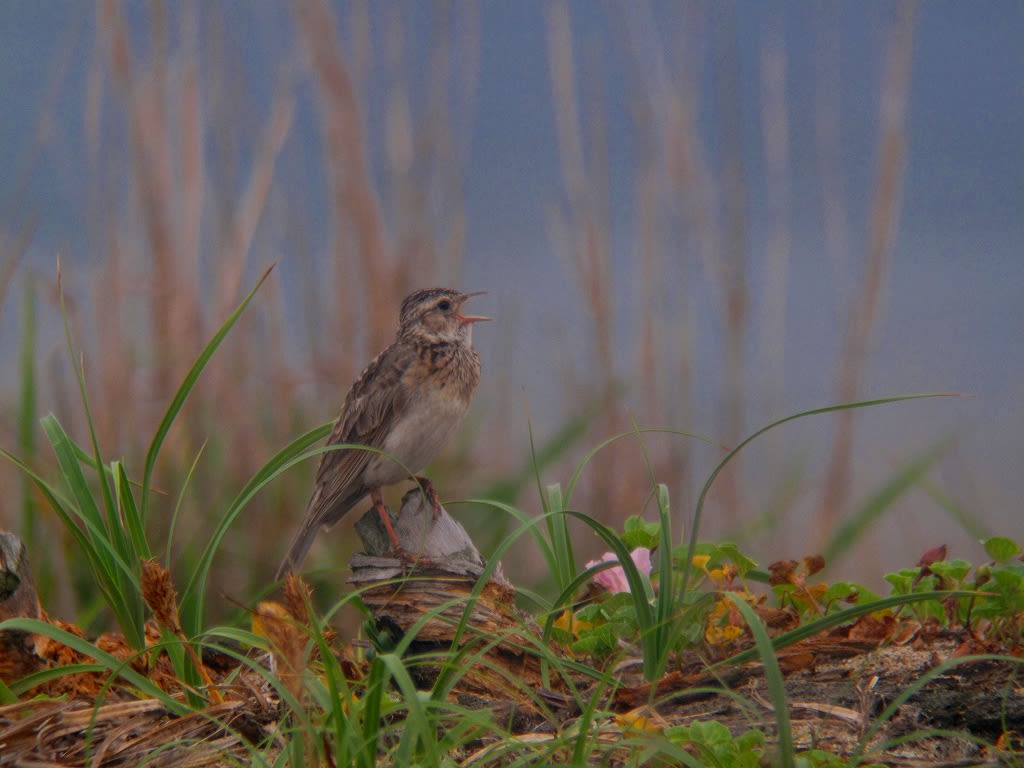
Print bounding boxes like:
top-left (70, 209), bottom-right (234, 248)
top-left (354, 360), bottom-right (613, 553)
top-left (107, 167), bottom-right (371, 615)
top-left (278, 288), bottom-right (490, 579)
